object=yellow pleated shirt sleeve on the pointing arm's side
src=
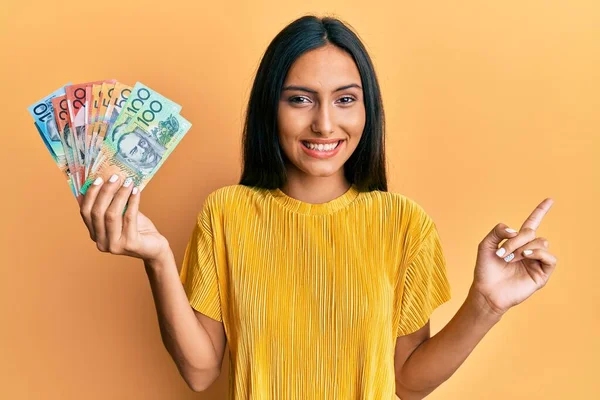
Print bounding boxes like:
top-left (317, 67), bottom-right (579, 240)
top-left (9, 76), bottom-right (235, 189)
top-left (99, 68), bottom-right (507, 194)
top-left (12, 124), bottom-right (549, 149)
top-left (396, 215), bottom-right (451, 336)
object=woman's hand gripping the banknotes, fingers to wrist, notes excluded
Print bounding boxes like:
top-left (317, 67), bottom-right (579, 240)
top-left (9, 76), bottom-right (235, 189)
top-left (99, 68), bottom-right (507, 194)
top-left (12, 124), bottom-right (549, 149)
top-left (77, 175), bottom-right (170, 261)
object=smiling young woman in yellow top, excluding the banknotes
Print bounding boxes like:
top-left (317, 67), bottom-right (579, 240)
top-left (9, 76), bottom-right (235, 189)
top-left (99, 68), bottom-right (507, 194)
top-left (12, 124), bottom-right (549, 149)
top-left (81, 16), bottom-right (556, 400)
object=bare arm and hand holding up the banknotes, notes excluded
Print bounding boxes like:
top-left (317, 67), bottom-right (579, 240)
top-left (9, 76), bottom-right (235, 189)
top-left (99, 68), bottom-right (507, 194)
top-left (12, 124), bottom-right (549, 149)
top-left (78, 175), bottom-right (225, 391)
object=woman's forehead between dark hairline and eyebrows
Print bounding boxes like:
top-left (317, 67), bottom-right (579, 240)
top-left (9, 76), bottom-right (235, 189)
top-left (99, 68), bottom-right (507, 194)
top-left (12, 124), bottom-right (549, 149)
top-left (285, 45), bottom-right (361, 89)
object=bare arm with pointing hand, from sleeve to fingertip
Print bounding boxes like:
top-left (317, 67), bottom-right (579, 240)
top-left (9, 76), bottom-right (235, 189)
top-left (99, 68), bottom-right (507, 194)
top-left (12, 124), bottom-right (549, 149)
top-left (395, 202), bottom-right (557, 400)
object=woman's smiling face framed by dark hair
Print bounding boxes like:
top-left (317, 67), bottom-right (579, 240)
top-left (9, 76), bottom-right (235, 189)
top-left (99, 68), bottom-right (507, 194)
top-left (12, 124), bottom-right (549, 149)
top-left (277, 45), bottom-right (365, 177)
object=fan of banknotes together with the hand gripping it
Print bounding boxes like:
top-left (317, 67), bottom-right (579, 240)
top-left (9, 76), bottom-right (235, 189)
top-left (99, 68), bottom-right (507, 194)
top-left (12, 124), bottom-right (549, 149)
top-left (28, 79), bottom-right (192, 261)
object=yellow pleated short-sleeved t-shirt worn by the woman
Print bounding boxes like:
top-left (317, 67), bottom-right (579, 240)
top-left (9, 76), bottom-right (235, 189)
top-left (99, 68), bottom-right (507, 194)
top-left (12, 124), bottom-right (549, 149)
top-left (180, 185), bottom-right (451, 400)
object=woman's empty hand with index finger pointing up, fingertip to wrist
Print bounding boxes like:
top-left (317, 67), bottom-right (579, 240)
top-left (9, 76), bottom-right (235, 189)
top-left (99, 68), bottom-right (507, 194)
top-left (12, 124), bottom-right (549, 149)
top-left (472, 198), bottom-right (558, 315)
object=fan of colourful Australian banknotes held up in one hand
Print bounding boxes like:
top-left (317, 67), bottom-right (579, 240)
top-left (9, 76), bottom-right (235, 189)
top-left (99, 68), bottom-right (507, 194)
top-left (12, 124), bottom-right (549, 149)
top-left (28, 79), bottom-right (192, 197)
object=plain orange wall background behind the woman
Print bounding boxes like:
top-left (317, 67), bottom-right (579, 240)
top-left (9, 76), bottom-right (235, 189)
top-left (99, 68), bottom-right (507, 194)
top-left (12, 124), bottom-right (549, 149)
top-left (0, 0), bottom-right (600, 399)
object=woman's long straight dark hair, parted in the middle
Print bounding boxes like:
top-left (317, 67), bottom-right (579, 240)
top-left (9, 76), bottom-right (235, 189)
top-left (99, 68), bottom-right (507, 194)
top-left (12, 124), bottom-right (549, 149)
top-left (240, 15), bottom-right (387, 192)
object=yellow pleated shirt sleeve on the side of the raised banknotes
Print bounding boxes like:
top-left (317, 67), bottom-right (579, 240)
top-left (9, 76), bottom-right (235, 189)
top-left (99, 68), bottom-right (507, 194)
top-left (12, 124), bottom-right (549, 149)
top-left (179, 201), bottom-right (223, 322)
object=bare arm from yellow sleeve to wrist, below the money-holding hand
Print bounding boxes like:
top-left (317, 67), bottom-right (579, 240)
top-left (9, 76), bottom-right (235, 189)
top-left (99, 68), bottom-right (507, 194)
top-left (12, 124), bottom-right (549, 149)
top-left (144, 249), bottom-right (225, 391)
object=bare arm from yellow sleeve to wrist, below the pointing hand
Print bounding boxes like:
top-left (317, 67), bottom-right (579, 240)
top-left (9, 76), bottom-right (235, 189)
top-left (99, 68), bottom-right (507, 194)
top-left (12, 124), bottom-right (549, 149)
top-left (396, 287), bottom-right (502, 400)
